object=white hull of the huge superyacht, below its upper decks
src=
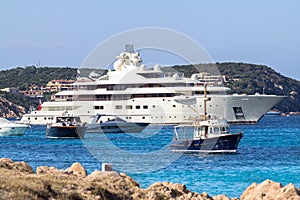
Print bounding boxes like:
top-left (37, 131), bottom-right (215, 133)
top-left (21, 95), bottom-right (284, 125)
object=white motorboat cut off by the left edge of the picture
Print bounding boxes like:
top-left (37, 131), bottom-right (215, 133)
top-left (0, 118), bottom-right (30, 136)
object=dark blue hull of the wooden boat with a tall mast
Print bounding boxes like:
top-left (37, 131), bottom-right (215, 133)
top-left (171, 133), bottom-right (243, 153)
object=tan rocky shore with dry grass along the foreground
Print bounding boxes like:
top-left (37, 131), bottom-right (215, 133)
top-left (0, 158), bottom-right (300, 200)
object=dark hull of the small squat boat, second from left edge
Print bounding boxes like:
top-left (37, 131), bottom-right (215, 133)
top-left (46, 126), bottom-right (85, 138)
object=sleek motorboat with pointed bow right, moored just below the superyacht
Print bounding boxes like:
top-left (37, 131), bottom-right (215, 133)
top-left (87, 114), bottom-right (149, 133)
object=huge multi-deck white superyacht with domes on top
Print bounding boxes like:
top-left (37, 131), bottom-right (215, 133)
top-left (21, 47), bottom-right (284, 125)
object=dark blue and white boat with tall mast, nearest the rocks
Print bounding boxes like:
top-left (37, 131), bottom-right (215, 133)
top-left (171, 87), bottom-right (243, 153)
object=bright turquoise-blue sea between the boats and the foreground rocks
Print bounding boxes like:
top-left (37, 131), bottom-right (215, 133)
top-left (0, 116), bottom-right (300, 197)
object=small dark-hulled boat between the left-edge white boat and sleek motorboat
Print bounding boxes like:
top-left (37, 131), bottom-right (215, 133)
top-left (46, 115), bottom-right (86, 138)
